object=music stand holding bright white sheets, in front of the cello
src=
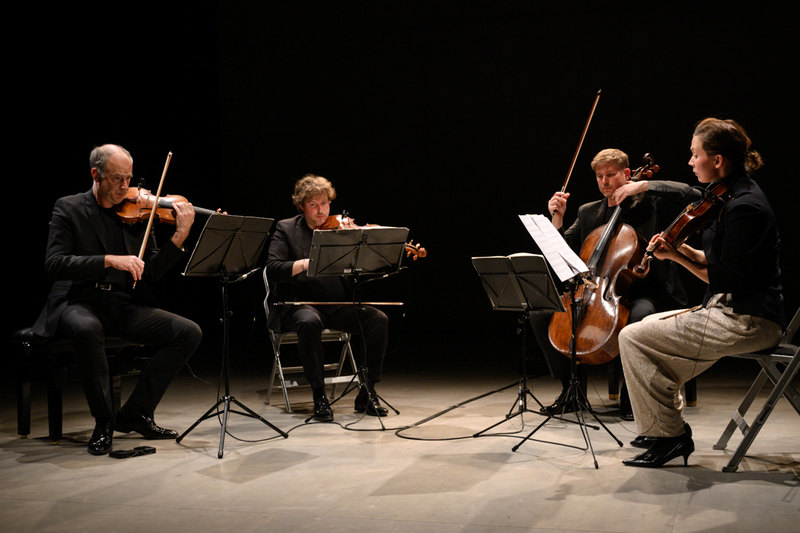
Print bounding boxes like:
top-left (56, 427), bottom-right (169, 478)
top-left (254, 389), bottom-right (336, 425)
top-left (511, 215), bottom-right (622, 468)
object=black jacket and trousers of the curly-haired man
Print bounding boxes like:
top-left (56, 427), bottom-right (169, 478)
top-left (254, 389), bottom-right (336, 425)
top-left (265, 214), bottom-right (389, 394)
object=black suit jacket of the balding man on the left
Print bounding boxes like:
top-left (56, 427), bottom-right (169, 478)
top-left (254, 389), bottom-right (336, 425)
top-left (33, 190), bottom-right (183, 337)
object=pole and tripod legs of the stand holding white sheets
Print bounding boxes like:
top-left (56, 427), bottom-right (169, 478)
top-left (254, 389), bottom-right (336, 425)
top-left (511, 278), bottom-right (622, 469)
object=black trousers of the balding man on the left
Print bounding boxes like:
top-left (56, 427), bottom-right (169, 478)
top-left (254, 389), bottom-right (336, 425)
top-left (59, 290), bottom-right (203, 423)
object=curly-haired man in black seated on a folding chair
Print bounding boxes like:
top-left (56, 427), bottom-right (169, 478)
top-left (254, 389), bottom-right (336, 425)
top-left (266, 174), bottom-right (389, 422)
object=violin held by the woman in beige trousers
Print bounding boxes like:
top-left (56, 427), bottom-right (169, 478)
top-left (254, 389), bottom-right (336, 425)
top-left (633, 180), bottom-right (731, 277)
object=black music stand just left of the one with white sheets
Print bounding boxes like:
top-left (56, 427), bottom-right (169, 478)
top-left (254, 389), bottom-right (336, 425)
top-left (472, 254), bottom-right (564, 437)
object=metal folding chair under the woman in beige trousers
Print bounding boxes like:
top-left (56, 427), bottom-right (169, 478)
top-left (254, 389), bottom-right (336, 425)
top-left (714, 309), bottom-right (800, 472)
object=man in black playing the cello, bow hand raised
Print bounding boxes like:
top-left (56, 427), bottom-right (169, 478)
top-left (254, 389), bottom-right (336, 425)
top-left (531, 148), bottom-right (696, 419)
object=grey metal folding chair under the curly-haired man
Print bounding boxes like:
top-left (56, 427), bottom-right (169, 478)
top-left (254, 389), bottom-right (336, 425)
top-left (263, 268), bottom-right (358, 413)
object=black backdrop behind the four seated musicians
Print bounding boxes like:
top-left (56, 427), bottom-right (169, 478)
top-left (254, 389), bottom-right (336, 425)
top-left (5, 2), bottom-right (800, 367)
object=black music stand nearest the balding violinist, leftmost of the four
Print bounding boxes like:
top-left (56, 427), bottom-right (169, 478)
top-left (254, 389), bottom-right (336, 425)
top-left (176, 215), bottom-right (289, 459)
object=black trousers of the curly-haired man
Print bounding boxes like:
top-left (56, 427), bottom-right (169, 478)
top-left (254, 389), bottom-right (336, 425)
top-left (281, 305), bottom-right (389, 392)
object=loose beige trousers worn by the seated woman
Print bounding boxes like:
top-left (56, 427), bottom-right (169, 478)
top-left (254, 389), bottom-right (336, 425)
top-left (619, 294), bottom-right (782, 437)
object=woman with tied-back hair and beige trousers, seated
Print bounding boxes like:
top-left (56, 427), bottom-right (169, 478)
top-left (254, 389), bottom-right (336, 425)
top-left (619, 118), bottom-right (784, 467)
